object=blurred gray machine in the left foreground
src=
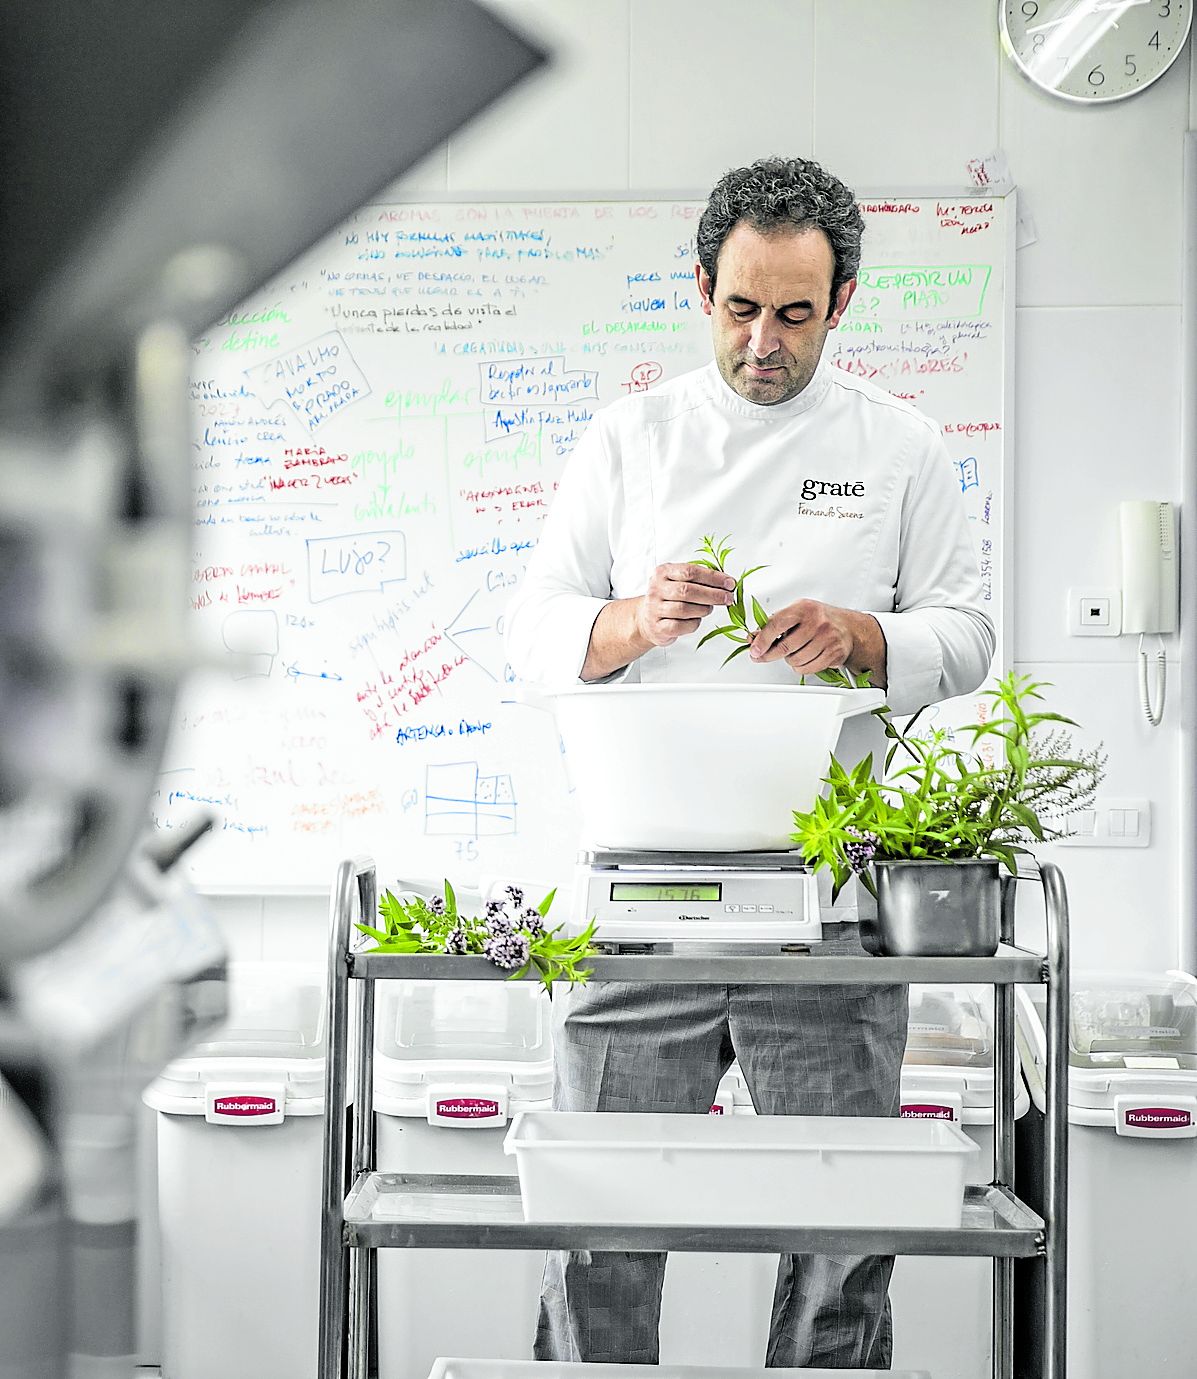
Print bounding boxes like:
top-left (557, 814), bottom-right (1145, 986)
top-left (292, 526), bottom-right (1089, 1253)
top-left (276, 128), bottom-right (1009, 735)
top-left (0, 0), bottom-right (542, 1379)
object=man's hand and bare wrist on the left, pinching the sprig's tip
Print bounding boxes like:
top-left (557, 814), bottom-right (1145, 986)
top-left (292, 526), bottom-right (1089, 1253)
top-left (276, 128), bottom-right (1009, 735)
top-left (582, 564), bottom-right (735, 680)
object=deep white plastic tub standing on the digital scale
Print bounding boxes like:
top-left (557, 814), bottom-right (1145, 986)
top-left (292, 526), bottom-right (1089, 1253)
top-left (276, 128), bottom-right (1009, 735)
top-left (524, 684), bottom-right (884, 852)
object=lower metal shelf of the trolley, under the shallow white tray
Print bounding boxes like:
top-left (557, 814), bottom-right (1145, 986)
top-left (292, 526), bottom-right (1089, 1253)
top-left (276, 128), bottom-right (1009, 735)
top-left (343, 1174), bottom-right (1044, 1259)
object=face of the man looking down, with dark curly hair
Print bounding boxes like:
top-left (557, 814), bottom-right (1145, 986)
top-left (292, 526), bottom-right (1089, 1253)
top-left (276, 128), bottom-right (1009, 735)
top-left (695, 221), bottom-right (856, 407)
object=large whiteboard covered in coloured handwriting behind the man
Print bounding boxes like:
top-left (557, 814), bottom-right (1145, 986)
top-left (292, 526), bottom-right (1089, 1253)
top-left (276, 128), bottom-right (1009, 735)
top-left (153, 196), bottom-right (1014, 892)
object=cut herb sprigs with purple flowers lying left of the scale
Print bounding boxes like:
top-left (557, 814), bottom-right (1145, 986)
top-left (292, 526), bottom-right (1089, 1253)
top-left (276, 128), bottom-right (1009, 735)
top-left (357, 880), bottom-right (597, 996)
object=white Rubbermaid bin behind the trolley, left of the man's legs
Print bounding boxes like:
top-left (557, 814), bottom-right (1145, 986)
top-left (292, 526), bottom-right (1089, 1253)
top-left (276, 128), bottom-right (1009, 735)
top-left (374, 982), bottom-right (553, 1379)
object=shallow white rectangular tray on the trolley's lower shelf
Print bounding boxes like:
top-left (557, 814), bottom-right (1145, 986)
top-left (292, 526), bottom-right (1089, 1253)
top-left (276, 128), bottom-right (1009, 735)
top-left (503, 1111), bottom-right (975, 1226)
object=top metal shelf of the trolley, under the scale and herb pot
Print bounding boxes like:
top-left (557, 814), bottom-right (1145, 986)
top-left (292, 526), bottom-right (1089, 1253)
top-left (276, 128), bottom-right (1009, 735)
top-left (349, 943), bottom-right (1045, 985)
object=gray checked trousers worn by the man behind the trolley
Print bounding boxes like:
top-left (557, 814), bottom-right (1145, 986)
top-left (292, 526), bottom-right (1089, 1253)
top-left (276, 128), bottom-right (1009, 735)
top-left (534, 925), bottom-right (907, 1369)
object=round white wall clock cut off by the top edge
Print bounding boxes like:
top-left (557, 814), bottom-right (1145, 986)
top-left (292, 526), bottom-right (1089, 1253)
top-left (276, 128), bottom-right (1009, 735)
top-left (998, 0), bottom-right (1193, 102)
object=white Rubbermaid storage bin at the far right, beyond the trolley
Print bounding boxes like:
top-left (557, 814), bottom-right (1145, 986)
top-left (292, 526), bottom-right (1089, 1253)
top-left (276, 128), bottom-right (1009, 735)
top-left (1018, 971), bottom-right (1197, 1379)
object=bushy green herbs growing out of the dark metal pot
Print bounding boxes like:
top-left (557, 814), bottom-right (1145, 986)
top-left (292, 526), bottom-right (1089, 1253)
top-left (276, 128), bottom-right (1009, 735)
top-left (793, 672), bottom-right (1107, 899)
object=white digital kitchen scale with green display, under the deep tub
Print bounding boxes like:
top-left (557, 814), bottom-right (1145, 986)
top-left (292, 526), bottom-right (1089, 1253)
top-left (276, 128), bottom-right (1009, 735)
top-left (572, 849), bottom-right (823, 943)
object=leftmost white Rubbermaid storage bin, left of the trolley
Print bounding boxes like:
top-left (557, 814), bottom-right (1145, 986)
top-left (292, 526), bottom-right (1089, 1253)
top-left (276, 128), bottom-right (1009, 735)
top-left (143, 963), bottom-right (325, 1379)
